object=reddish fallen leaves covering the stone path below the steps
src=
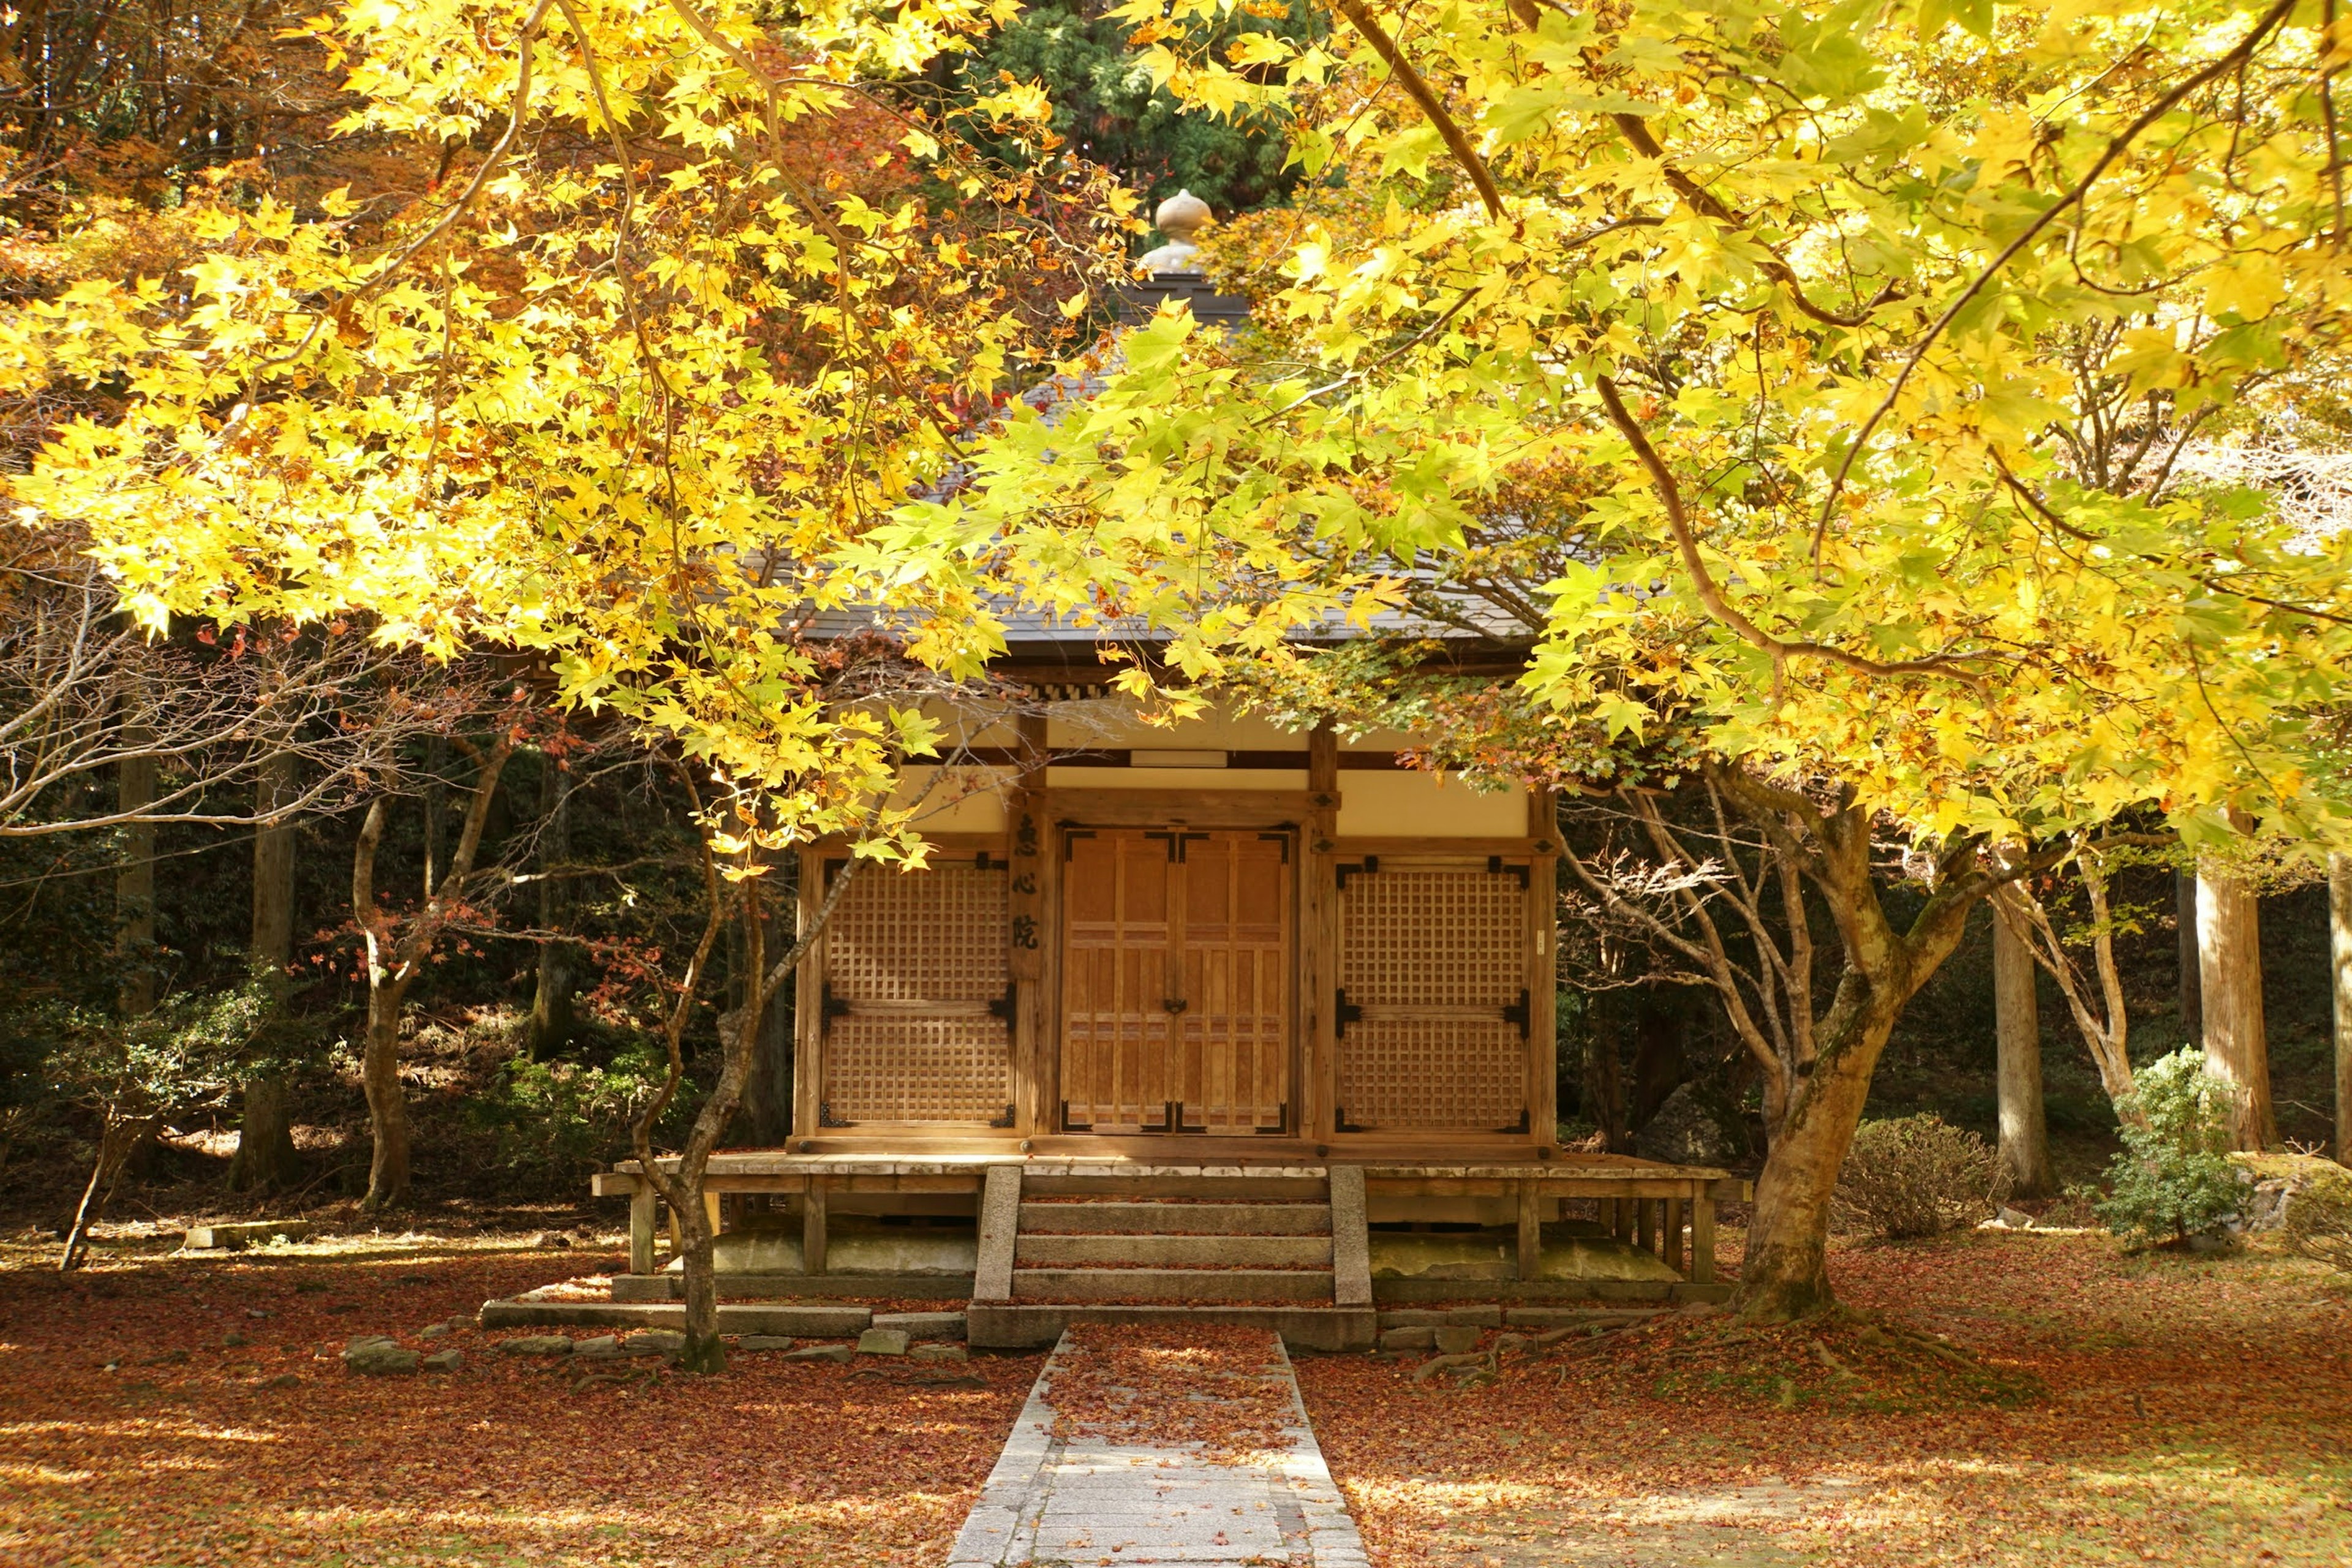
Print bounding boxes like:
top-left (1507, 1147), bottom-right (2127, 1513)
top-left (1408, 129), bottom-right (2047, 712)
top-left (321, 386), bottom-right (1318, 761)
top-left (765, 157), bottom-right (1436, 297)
top-left (1049, 1324), bottom-right (1296, 1460)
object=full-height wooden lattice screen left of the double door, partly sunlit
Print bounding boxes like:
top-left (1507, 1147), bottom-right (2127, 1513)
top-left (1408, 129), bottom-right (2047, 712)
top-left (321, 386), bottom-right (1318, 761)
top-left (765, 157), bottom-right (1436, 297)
top-left (818, 858), bottom-right (1014, 1126)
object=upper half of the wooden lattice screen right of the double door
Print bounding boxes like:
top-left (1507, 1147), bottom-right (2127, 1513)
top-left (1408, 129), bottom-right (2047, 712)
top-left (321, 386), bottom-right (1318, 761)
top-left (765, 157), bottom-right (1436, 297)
top-left (1338, 867), bottom-right (1526, 1009)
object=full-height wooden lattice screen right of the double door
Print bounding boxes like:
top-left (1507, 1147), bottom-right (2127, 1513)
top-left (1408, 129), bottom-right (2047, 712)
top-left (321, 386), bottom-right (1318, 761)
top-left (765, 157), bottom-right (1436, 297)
top-left (1336, 858), bottom-right (1531, 1131)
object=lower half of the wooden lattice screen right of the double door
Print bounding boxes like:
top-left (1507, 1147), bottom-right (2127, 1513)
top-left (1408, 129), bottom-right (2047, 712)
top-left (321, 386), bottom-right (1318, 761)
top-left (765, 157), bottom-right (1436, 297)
top-left (1338, 1018), bottom-right (1526, 1131)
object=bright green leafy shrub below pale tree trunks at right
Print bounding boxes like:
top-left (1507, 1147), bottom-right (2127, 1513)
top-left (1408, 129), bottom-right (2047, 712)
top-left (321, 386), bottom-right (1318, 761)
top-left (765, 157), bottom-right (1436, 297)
top-left (2094, 1046), bottom-right (2246, 1243)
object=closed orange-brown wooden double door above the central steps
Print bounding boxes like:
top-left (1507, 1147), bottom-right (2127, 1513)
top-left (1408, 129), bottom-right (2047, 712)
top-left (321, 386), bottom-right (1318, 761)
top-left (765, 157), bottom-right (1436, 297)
top-left (1061, 827), bottom-right (1298, 1133)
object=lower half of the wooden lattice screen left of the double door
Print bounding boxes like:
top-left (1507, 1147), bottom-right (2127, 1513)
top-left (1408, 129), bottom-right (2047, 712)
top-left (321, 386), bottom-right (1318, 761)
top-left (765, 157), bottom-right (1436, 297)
top-left (826, 1013), bottom-right (1014, 1121)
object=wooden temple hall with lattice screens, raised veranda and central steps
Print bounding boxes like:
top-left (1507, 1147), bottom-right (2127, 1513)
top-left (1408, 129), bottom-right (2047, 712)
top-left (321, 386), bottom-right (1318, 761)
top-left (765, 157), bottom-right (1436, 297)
top-left (597, 691), bottom-right (1741, 1347)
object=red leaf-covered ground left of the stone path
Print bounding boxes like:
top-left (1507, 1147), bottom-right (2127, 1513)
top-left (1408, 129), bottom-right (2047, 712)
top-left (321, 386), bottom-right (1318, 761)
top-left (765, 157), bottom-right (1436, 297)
top-left (0, 1243), bottom-right (1037, 1568)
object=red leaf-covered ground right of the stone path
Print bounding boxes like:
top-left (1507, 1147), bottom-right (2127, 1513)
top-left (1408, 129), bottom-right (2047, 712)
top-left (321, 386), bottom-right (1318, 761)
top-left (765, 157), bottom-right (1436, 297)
top-left (1298, 1234), bottom-right (2352, 1568)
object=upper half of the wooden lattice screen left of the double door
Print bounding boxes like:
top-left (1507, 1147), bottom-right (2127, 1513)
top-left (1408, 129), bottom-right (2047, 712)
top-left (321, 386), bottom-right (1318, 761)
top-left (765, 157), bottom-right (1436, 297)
top-left (826, 863), bottom-right (1011, 1004)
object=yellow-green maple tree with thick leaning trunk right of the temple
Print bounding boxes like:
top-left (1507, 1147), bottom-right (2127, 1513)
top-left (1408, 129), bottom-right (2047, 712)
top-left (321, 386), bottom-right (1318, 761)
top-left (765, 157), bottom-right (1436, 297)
top-left (891, 0), bottom-right (2352, 1314)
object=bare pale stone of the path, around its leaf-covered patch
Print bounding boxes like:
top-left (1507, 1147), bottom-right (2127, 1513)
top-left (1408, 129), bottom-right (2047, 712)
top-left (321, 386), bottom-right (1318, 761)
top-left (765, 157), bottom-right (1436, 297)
top-left (948, 1333), bottom-right (1364, 1568)
